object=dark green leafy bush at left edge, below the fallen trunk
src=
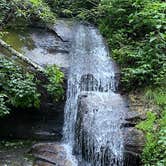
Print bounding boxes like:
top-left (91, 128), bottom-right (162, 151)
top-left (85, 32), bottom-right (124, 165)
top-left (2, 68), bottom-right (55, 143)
top-left (0, 58), bottom-right (40, 116)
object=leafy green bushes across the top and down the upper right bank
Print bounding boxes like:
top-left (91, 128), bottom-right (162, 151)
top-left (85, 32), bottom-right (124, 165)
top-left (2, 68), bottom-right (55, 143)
top-left (0, 0), bottom-right (166, 91)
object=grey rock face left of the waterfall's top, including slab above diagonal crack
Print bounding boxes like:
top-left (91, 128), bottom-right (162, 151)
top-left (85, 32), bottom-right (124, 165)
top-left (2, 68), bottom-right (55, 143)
top-left (22, 20), bottom-right (74, 78)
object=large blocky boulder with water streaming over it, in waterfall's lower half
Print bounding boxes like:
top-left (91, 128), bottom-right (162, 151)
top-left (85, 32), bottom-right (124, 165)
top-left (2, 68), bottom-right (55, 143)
top-left (75, 92), bottom-right (127, 166)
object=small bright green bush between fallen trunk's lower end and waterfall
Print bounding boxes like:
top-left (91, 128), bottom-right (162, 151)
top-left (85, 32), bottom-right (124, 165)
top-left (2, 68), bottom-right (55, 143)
top-left (46, 66), bottom-right (64, 101)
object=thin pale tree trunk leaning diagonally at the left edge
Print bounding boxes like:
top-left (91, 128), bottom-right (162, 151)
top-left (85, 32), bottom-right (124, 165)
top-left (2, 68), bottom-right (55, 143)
top-left (0, 39), bottom-right (44, 73)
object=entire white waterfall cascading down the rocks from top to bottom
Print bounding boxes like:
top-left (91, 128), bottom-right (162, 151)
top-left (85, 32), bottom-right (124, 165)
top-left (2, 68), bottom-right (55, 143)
top-left (64, 24), bottom-right (125, 166)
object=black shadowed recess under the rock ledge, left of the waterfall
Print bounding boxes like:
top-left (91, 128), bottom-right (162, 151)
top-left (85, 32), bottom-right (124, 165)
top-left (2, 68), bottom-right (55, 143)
top-left (0, 102), bottom-right (64, 141)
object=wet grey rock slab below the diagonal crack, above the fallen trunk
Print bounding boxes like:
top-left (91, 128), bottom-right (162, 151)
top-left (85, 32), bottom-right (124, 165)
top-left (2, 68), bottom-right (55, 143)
top-left (23, 29), bottom-right (71, 72)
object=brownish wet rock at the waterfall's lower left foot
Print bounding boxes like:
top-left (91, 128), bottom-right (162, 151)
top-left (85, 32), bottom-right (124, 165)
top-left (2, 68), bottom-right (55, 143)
top-left (31, 143), bottom-right (72, 166)
